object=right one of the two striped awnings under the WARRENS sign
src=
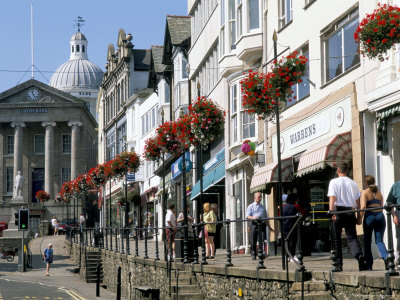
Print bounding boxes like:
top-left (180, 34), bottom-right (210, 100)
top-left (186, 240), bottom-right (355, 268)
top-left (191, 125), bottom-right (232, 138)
top-left (296, 132), bottom-right (352, 176)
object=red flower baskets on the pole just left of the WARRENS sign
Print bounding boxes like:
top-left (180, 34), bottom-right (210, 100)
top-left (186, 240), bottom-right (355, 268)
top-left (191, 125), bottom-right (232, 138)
top-left (240, 51), bottom-right (307, 119)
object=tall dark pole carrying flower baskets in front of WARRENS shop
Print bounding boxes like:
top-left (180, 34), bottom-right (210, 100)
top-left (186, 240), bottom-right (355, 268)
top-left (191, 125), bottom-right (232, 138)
top-left (272, 31), bottom-right (286, 270)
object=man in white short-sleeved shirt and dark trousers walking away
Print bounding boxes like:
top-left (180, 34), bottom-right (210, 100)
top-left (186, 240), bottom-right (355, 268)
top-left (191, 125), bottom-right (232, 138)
top-left (328, 162), bottom-right (367, 272)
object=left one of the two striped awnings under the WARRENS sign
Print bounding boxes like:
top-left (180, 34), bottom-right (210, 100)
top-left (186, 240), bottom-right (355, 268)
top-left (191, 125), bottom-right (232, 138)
top-left (250, 157), bottom-right (293, 193)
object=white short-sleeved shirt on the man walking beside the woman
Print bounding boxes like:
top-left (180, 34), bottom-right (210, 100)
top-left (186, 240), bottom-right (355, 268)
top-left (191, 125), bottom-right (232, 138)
top-left (328, 176), bottom-right (360, 208)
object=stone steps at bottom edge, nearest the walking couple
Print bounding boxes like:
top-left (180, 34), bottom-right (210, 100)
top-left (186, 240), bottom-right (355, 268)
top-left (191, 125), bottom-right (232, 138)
top-left (290, 281), bottom-right (334, 300)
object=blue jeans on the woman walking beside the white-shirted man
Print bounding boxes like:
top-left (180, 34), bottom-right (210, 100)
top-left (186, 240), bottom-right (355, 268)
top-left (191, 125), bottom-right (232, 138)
top-left (363, 211), bottom-right (388, 268)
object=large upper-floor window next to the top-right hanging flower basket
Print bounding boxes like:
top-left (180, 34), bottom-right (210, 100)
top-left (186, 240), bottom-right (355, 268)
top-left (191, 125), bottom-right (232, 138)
top-left (322, 8), bottom-right (360, 82)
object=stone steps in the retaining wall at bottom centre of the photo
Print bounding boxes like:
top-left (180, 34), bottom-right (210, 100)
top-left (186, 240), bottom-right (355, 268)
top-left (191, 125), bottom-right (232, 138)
top-left (171, 271), bottom-right (204, 300)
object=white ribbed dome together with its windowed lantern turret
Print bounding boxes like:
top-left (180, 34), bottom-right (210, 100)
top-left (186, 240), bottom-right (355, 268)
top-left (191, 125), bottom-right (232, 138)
top-left (50, 31), bottom-right (103, 91)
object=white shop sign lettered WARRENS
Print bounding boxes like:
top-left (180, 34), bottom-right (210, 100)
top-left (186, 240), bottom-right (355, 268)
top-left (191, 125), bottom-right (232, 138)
top-left (287, 115), bottom-right (330, 149)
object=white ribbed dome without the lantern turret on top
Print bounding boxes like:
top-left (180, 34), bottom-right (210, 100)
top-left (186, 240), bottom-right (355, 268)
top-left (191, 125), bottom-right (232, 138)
top-left (50, 59), bottom-right (103, 90)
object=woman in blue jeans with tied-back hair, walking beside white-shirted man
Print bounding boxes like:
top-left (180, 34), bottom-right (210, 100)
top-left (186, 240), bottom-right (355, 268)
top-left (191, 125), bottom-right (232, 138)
top-left (358, 175), bottom-right (388, 271)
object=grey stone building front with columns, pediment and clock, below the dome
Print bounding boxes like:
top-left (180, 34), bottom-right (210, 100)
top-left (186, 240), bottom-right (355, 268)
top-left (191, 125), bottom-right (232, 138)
top-left (0, 79), bottom-right (97, 218)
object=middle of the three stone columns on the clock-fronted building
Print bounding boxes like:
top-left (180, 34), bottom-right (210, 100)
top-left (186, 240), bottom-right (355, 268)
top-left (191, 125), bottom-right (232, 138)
top-left (42, 122), bottom-right (56, 197)
